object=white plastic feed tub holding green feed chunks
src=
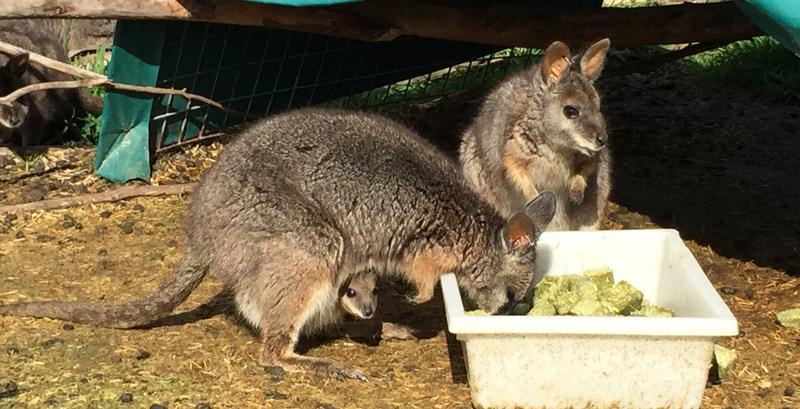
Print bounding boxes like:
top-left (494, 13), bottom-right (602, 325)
top-left (441, 229), bottom-right (738, 408)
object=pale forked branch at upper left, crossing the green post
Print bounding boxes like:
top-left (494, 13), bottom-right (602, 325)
top-left (0, 41), bottom-right (257, 119)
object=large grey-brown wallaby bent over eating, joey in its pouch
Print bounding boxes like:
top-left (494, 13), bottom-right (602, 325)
top-left (0, 109), bottom-right (556, 379)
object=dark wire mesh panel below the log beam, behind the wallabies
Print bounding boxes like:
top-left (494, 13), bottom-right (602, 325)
top-left (151, 23), bottom-right (535, 152)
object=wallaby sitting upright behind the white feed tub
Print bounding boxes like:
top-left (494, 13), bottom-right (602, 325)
top-left (459, 39), bottom-right (611, 230)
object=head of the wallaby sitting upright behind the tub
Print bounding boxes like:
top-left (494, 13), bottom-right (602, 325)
top-left (538, 39), bottom-right (611, 156)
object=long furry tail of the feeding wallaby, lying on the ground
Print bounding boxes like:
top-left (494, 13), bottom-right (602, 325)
top-left (0, 253), bottom-right (208, 328)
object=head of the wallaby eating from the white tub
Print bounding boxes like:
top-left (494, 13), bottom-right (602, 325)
top-left (460, 191), bottom-right (556, 314)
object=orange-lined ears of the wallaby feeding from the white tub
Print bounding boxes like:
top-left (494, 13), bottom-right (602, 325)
top-left (502, 191), bottom-right (556, 251)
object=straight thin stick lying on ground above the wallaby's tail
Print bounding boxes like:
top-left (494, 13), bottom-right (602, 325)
top-left (0, 183), bottom-right (195, 214)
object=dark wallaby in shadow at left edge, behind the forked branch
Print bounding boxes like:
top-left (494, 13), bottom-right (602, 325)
top-left (0, 19), bottom-right (79, 159)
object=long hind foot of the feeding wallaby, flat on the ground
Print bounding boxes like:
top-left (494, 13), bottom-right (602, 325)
top-left (259, 343), bottom-right (368, 381)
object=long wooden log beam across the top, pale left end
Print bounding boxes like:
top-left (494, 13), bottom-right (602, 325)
top-left (0, 0), bottom-right (762, 48)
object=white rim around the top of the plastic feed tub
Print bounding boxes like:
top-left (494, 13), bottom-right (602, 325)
top-left (440, 229), bottom-right (739, 337)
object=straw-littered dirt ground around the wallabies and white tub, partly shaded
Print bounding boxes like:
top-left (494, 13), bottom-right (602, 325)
top-left (0, 55), bottom-right (800, 409)
